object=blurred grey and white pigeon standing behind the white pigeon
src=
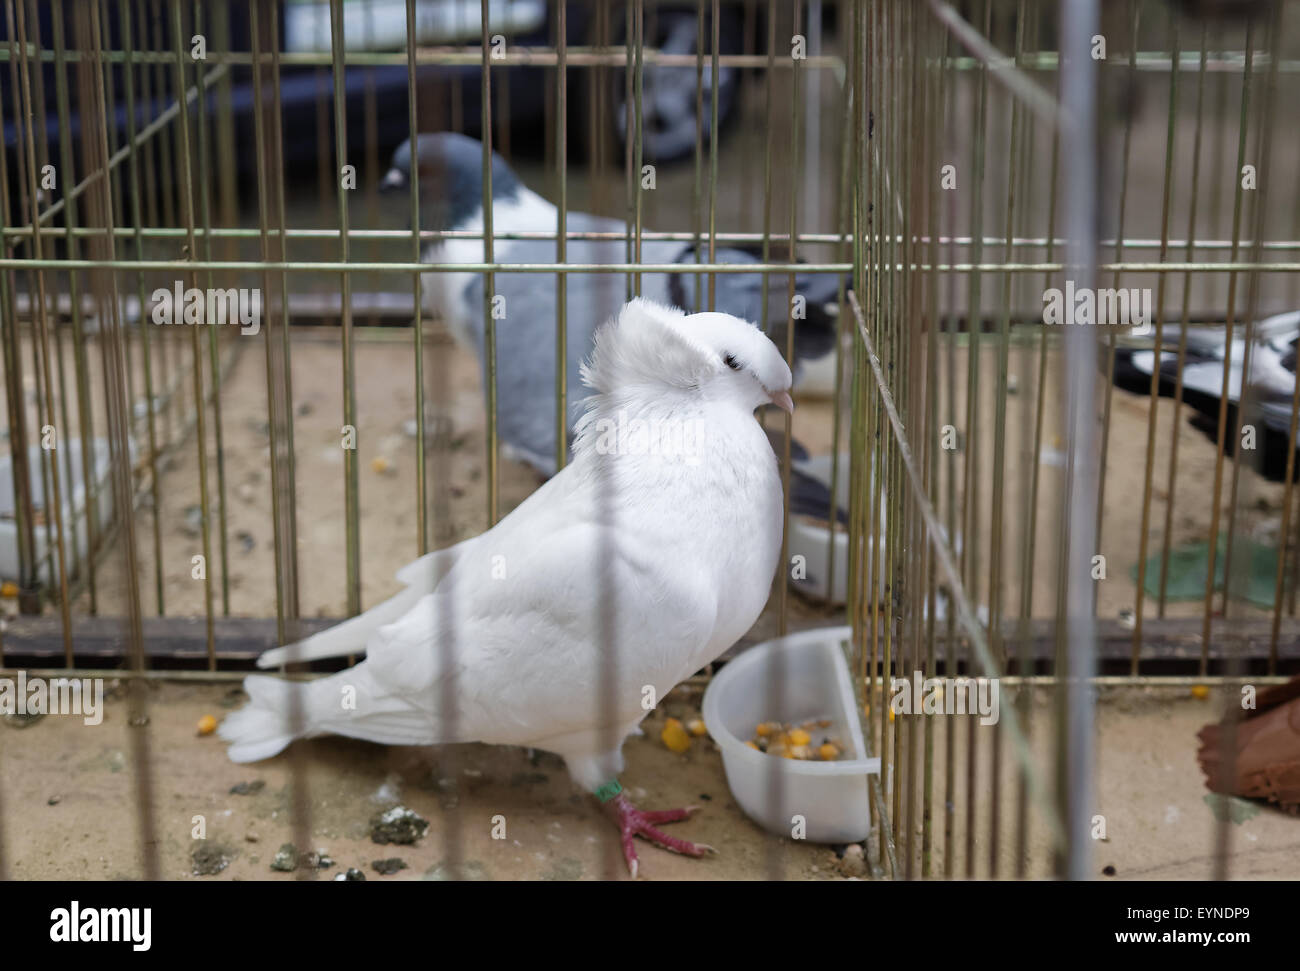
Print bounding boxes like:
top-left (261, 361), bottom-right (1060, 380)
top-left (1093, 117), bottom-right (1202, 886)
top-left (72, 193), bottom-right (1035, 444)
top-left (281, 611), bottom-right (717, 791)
top-left (381, 133), bottom-right (840, 488)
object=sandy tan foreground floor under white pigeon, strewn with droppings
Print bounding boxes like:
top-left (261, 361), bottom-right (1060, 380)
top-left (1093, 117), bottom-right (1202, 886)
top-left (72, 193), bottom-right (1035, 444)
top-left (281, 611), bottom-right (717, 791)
top-left (0, 684), bottom-right (1300, 880)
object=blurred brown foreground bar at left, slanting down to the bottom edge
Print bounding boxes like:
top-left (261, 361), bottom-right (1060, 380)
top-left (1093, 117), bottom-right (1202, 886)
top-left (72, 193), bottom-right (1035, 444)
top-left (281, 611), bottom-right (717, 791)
top-left (75, 0), bottom-right (158, 880)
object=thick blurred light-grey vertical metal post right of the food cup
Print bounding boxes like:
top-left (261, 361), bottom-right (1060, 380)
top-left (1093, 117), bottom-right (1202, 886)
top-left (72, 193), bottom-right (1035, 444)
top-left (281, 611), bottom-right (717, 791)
top-left (1061, 0), bottom-right (1099, 880)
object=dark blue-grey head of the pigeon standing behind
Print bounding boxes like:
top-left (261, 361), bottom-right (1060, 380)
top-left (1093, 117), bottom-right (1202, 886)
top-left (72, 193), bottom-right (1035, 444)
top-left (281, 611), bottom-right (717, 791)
top-left (380, 131), bottom-right (523, 231)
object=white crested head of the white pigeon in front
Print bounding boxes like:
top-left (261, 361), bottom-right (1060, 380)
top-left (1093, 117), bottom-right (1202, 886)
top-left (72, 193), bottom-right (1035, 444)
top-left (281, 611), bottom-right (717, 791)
top-left (582, 298), bottom-right (794, 412)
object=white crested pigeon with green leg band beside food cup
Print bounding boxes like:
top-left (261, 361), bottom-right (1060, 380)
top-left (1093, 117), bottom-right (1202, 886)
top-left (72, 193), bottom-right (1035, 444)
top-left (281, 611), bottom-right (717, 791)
top-left (221, 299), bottom-right (793, 876)
